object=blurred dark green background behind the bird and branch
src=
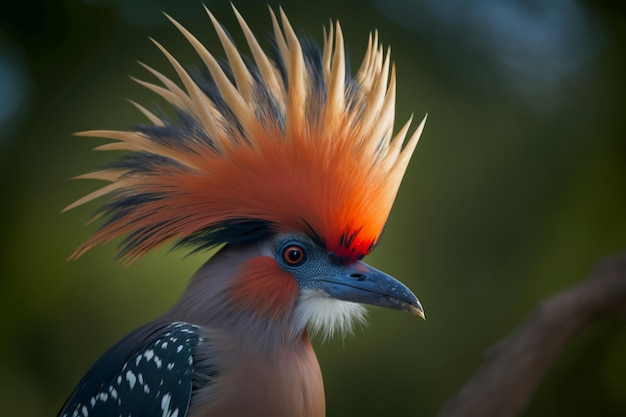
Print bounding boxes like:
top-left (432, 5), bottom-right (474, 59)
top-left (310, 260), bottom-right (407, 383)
top-left (0, 0), bottom-right (626, 416)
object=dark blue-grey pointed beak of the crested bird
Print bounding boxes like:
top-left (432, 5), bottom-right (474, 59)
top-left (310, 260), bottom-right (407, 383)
top-left (316, 261), bottom-right (425, 318)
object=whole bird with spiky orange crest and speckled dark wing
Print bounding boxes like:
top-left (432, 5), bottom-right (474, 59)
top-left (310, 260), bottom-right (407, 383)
top-left (58, 6), bottom-right (426, 417)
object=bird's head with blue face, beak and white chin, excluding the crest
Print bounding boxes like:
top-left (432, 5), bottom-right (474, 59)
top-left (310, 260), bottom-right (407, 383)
top-left (195, 232), bottom-right (424, 340)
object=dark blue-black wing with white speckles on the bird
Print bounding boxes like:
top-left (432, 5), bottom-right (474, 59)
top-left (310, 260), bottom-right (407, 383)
top-left (58, 322), bottom-right (210, 417)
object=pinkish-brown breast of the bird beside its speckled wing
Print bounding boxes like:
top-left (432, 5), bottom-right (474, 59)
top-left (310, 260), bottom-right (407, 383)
top-left (189, 334), bottom-right (325, 417)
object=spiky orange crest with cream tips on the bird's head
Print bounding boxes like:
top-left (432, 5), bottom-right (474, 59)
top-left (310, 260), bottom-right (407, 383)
top-left (66, 4), bottom-right (425, 261)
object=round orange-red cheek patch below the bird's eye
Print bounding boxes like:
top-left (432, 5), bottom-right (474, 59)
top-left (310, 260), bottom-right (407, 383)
top-left (232, 256), bottom-right (299, 318)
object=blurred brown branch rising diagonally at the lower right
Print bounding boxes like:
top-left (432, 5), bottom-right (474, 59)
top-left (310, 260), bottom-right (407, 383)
top-left (439, 252), bottom-right (626, 417)
